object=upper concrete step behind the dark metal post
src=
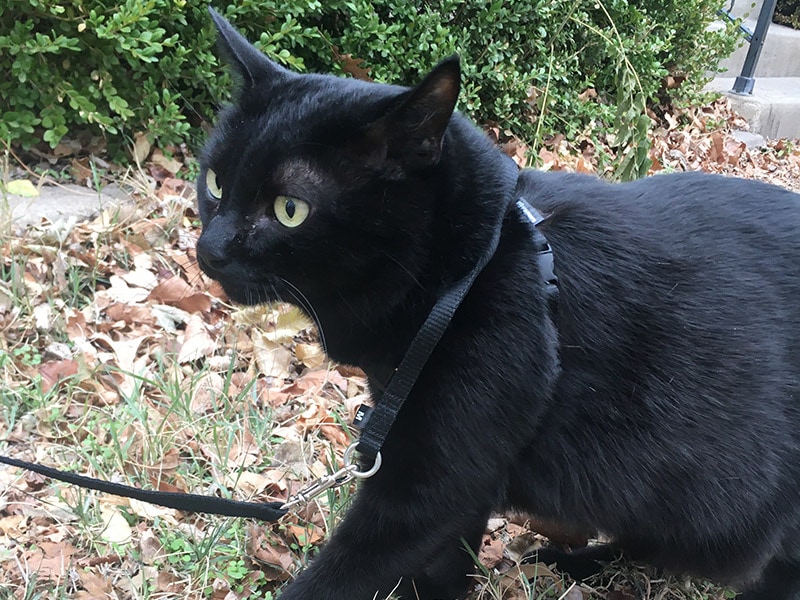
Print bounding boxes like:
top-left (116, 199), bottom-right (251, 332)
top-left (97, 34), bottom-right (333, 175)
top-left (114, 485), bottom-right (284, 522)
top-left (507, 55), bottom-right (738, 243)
top-left (720, 22), bottom-right (800, 78)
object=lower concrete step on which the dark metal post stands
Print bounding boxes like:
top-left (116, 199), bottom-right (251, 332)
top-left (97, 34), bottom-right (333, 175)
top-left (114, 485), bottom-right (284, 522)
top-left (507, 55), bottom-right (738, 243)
top-left (707, 77), bottom-right (800, 139)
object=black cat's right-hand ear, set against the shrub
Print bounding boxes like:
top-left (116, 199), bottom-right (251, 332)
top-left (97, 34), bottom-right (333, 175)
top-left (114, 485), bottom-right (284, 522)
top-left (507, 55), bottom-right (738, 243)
top-left (387, 56), bottom-right (461, 167)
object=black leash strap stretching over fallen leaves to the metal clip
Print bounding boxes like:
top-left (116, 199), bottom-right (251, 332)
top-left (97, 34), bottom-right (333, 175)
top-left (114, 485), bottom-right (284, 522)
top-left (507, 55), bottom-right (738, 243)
top-left (0, 456), bottom-right (287, 521)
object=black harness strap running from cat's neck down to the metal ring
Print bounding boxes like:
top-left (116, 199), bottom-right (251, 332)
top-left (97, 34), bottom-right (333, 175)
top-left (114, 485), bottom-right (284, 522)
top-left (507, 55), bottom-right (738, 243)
top-left (358, 159), bottom-right (519, 461)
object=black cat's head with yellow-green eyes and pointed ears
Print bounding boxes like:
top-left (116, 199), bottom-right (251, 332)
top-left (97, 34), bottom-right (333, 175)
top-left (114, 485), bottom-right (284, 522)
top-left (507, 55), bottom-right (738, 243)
top-left (197, 11), bottom-right (460, 319)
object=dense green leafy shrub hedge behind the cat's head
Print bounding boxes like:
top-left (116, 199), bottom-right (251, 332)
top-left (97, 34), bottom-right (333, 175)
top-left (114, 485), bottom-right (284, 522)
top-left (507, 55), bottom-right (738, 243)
top-left (0, 0), bottom-right (734, 173)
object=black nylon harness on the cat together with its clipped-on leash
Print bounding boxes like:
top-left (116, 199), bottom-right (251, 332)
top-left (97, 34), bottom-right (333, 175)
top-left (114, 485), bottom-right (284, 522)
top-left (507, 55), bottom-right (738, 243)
top-left (0, 159), bottom-right (558, 521)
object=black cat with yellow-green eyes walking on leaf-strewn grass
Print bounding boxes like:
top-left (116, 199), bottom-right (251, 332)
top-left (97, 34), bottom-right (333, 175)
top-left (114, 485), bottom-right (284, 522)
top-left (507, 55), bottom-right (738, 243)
top-left (197, 9), bottom-right (800, 600)
